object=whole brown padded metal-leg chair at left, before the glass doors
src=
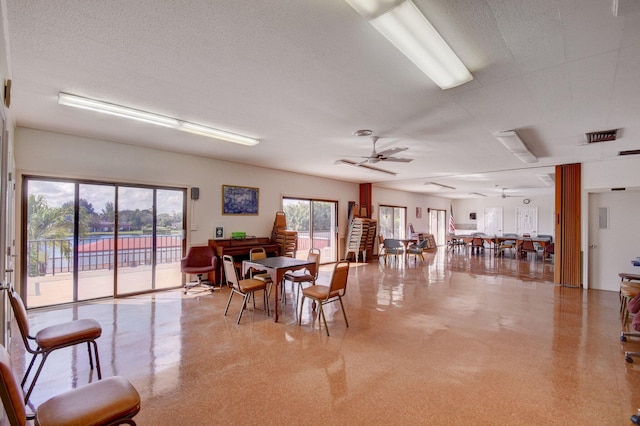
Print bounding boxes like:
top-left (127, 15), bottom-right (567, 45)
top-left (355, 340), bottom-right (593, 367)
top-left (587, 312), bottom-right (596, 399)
top-left (9, 288), bottom-right (102, 402)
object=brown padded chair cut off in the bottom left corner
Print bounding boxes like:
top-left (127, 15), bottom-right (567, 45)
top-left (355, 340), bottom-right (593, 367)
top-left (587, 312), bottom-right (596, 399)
top-left (0, 345), bottom-right (140, 426)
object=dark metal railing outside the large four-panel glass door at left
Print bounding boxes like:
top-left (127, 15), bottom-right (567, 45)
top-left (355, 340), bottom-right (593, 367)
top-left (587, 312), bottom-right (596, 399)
top-left (27, 235), bottom-right (182, 277)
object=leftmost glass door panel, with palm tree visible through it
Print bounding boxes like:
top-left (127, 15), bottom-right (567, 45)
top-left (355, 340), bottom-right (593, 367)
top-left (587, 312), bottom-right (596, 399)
top-left (23, 180), bottom-right (75, 308)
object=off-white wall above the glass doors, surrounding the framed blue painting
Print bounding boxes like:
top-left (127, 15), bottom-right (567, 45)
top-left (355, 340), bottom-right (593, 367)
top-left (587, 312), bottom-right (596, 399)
top-left (15, 128), bottom-right (359, 245)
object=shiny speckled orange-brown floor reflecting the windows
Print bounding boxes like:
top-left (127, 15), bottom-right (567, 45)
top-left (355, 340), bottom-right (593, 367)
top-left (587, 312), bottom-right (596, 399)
top-left (6, 250), bottom-right (640, 425)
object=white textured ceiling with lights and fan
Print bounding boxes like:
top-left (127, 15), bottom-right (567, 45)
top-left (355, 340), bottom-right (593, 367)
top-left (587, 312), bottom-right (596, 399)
top-left (6, 0), bottom-right (640, 198)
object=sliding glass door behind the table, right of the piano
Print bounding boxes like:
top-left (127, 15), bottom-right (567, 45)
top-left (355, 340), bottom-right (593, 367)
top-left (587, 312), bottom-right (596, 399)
top-left (282, 197), bottom-right (338, 263)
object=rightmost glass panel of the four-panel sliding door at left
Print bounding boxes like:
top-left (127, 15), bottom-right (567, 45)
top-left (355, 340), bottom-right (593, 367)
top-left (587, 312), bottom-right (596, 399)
top-left (155, 189), bottom-right (186, 289)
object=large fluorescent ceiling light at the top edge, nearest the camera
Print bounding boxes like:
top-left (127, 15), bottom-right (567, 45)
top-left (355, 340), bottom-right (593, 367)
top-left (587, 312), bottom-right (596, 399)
top-left (346, 0), bottom-right (473, 89)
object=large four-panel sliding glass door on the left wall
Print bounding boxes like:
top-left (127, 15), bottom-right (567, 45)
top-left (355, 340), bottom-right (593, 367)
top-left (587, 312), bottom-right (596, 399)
top-left (23, 177), bottom-right (186, 307)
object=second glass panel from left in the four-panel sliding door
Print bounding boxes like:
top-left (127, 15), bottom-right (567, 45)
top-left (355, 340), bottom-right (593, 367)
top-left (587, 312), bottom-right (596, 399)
top-left (77, 184), bottom-right (116, 300)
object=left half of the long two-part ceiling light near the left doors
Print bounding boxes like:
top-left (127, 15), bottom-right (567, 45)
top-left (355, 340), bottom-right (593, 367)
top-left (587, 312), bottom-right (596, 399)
top-left (58, 92), bottom-right (180, 129)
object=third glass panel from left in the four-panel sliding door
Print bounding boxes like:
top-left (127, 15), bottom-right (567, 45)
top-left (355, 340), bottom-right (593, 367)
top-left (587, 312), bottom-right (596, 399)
top-left (116, 186), bottom-right (155, 295)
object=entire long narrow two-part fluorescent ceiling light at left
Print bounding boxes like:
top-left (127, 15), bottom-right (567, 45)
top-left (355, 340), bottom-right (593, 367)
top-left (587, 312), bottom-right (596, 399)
top-left (58, 92), bottom-right (260, 146)
